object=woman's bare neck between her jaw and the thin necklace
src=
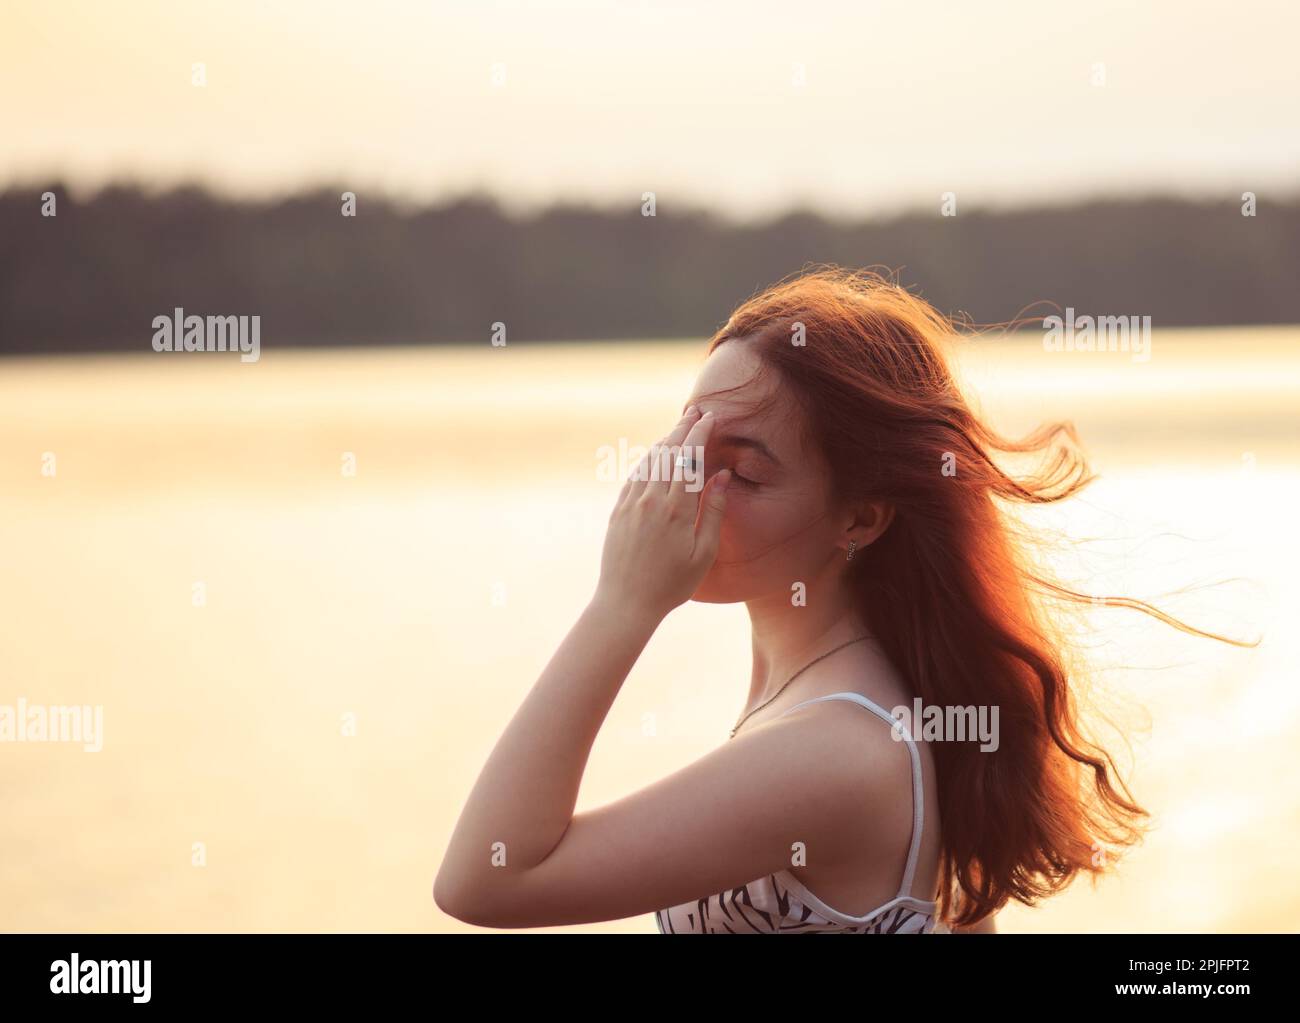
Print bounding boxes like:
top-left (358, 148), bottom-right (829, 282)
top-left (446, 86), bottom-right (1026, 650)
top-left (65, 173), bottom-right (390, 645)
top-left (745, 573), bottom-right (870, 712)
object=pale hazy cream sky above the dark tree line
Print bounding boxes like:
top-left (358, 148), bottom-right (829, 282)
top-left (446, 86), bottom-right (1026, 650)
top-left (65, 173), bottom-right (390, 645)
top-left (0, 0), bottom-right (1300, 216)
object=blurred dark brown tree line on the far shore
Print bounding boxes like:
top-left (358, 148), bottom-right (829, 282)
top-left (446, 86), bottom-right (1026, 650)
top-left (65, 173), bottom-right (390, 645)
top-left (0, 186), bottom-right (1300, 352)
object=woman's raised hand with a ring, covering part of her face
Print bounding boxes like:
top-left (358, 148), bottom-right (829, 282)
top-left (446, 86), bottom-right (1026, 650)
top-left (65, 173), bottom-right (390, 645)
top-left (597, 406), bottom-right (731, 621)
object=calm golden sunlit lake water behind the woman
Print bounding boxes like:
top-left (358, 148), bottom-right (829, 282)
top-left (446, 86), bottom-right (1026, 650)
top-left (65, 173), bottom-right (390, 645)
top-left (0, 328), bottom-right (1300, 932)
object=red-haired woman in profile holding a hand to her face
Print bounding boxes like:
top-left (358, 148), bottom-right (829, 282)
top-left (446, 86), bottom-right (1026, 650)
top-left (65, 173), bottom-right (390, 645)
top-left (433, 268), bottom-right (1235, 933)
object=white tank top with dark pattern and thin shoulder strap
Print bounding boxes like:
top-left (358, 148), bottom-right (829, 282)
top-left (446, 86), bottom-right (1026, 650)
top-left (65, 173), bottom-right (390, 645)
top-left (655, 693), bottom-right (948, 935)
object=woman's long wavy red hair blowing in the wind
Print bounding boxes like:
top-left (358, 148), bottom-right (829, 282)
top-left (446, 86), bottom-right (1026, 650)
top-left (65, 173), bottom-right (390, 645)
top-left (709, 265), bottom-right (1252, 926)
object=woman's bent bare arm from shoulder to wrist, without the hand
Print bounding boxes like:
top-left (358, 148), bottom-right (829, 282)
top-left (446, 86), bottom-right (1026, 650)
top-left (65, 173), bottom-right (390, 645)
top-left (434, 629), bottom-right (907, 928)
